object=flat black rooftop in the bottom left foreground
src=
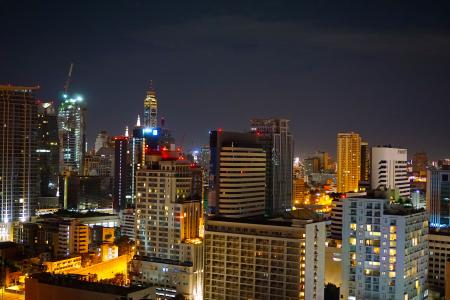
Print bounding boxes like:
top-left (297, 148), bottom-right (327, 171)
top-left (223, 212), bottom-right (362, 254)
top-left (31, 273), bottom-right (146, 296)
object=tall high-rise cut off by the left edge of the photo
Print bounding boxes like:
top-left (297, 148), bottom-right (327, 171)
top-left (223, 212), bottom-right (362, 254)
top-left (0, 85), bottom-right (39, 237)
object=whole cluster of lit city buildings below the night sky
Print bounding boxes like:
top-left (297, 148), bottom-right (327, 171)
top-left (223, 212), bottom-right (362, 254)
top-left (0, 85), bottom-right (450, 300)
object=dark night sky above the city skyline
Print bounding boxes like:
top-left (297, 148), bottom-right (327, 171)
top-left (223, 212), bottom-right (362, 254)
top-left (0, 0), bottom-right (450, 159)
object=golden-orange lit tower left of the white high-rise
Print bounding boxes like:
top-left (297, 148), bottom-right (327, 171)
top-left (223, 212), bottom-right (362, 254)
top-left (337, 132), bottom-right (361, 193)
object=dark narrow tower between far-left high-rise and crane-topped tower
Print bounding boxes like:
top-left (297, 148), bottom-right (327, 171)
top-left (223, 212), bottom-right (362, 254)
top-left (36, 101), bottom-right (59, 197)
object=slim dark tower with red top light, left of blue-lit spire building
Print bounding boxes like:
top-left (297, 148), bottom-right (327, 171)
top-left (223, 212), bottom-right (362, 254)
top-left (113, 136), bottom-right (132, 211)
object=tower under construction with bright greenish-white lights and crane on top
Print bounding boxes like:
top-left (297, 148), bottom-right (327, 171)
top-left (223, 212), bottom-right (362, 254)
top-left (58, 94), bottom-right (86, 174)
